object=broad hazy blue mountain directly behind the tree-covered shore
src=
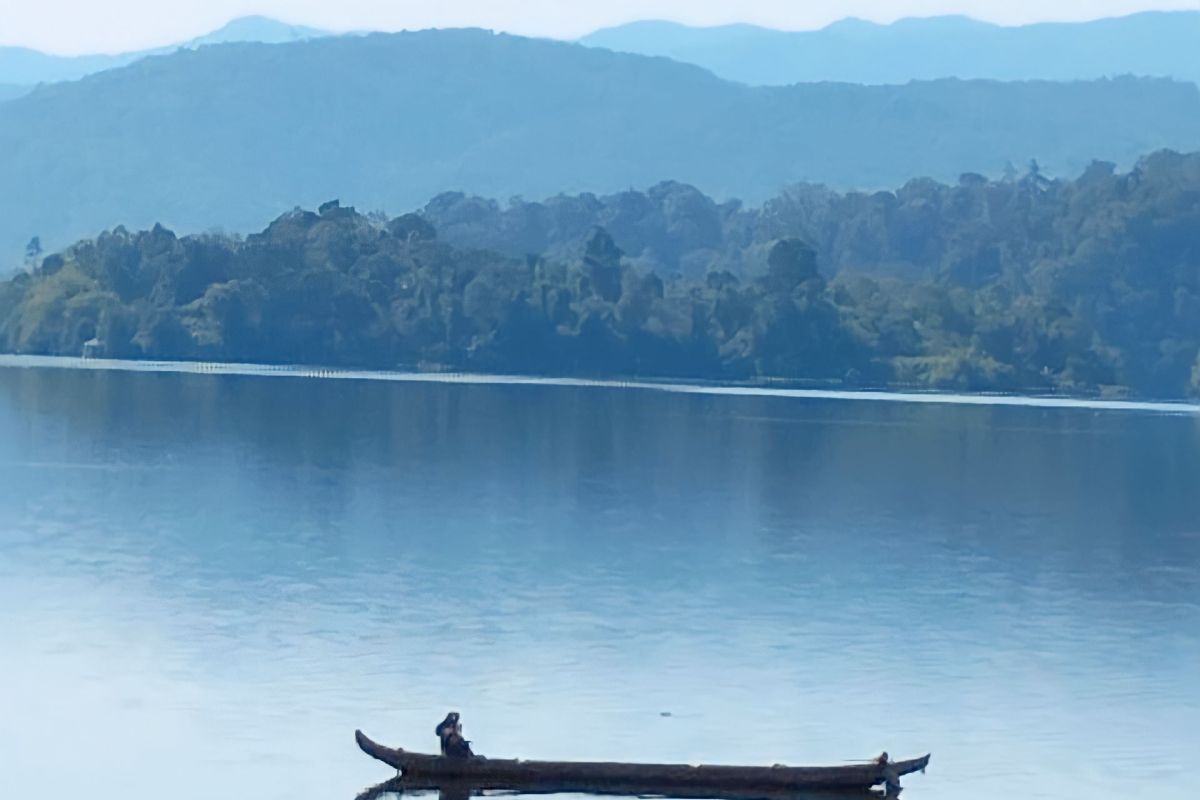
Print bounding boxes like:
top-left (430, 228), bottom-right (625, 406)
top-left (0, 30), bottom-right (1200, 260)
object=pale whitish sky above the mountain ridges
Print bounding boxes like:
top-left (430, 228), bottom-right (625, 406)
top-left (0, 0), bottom-right (1200, 54)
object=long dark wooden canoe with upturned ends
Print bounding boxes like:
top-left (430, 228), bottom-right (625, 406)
top-left (354, 730), bottom-right (929, 796)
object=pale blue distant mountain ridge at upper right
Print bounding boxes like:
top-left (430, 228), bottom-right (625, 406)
top-left (580, 11), bottom-right (1200, 85)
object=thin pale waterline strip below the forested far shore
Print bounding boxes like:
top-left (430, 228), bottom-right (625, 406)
top-left (0, 354), bottom-right (1200, 415)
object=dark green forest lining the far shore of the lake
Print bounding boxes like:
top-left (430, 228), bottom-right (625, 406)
top-left (0, 152), bottom-right (1200, 397)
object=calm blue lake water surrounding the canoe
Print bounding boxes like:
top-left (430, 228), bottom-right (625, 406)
top-left (0, 367), bottom-right (1200, 800)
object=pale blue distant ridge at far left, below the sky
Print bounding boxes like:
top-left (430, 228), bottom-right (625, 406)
top-left (0, 17), bottom-right (330, 86)
